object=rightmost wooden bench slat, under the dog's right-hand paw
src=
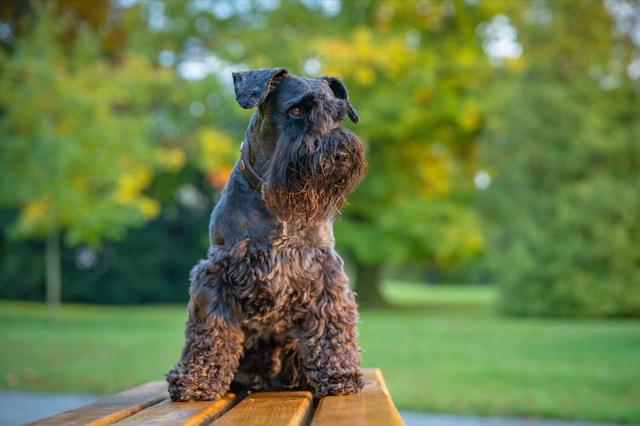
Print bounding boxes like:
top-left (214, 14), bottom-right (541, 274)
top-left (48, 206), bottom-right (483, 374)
top-left (311, 368), bottom-right (405, 426)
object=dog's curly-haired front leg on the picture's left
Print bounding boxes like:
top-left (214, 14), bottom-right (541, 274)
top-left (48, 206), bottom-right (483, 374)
top-left (167, 260), bottom-right (244, 401)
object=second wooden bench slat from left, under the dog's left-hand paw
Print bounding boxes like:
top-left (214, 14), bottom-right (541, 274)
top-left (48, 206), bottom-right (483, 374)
top-left (118, 393), bottom-right (236, 426)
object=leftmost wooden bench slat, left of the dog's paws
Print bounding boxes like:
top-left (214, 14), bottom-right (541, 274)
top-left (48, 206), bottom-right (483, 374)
top-left (29, 381), bottom-right (169, 426)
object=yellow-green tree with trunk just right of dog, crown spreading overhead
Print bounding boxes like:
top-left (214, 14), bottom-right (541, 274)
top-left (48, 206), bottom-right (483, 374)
top-left (172, 1), bottom-right (501, 306)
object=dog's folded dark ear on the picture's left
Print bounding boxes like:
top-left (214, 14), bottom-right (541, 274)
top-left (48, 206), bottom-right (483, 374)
top-left (232, 68), bottom-right (288, 109)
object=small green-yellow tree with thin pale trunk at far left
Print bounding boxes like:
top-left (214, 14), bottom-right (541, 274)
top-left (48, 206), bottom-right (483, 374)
top-left (0, 3), bottom-right (185, 308)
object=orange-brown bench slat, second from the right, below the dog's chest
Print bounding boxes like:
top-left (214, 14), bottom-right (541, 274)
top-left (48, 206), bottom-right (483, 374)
top-left (213, 391), bottom-right (313, 426)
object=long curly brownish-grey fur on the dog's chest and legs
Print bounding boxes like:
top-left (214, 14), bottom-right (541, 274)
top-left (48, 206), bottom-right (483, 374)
top-left (167, 236), bottom-right (362, 401)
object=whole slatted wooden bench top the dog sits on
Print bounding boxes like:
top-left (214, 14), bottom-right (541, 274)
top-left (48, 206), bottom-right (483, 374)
top-left (29, 369), bottom-right (404, 426)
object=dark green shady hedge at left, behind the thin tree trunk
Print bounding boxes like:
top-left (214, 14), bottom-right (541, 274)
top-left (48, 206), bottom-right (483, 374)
top-left (0, 166), bottom-right (214, 304)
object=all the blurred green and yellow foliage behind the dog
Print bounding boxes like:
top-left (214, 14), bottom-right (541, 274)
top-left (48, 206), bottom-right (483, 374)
top-left (0, 0), bottom-right (640, 316)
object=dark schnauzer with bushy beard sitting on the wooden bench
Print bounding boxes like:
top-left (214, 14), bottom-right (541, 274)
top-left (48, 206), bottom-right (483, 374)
top-left (166, 68), bottom-right (366, 401)
